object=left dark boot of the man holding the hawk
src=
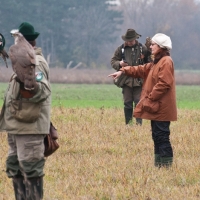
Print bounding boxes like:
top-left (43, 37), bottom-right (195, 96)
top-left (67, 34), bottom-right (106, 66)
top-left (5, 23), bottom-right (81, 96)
top-left (12, 175), bottom-right (26, 200)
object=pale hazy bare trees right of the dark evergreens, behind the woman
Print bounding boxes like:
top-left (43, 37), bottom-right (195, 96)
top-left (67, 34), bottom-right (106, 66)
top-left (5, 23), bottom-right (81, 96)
top-left (120, 0), bottom-right (200, 69)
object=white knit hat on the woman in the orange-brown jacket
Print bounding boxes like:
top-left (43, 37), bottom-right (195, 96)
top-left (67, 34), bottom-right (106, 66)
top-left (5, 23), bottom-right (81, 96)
top-left (151, 33), bottom-right (172, 50)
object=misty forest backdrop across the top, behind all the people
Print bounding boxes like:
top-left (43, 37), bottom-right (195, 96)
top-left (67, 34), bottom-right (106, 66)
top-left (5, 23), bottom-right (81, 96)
top-left (0, 0), bottom-right (200, 70)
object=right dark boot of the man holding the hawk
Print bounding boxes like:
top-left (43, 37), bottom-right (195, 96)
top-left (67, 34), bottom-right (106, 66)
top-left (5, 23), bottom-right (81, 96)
top-left (25, 176), bottom-right (43, 200)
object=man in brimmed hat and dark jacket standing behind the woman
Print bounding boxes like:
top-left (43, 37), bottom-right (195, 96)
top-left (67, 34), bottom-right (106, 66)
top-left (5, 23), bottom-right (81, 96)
top-left (111, 29), bottom-right (151, 125)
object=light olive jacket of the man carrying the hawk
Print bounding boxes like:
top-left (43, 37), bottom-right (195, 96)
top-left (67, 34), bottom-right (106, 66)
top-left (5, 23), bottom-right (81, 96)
top-left (0, 48), bottom-right (51, 134)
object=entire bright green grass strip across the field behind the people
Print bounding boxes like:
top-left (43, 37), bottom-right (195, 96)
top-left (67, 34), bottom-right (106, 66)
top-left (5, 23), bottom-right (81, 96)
top-left (0, 83), bottom-right (200, 109)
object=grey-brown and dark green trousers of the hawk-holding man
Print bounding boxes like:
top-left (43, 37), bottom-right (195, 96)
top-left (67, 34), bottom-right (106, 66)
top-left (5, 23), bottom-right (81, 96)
top-left (6, 134), bottom-right (45, 178)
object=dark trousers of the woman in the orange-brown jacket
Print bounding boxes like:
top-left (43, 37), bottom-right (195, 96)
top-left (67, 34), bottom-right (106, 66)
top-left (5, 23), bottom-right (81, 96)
top-left (151, 120), bottom-right (173, 157)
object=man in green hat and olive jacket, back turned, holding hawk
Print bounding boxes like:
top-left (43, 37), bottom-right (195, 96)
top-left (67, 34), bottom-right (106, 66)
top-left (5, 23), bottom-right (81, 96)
top-left (0, 22), bottom-right (51, 200)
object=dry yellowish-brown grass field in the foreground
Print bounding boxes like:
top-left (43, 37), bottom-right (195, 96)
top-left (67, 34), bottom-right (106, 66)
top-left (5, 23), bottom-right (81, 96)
top-left (0, 107), bottom-right (200, 200)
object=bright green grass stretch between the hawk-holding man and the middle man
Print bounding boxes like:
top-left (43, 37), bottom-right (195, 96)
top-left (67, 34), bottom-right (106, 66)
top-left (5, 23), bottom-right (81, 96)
top-left (52, 84), bottom-right (123, 108)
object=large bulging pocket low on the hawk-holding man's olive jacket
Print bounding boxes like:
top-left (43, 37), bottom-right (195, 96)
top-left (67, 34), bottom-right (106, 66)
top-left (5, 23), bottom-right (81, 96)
top-left (9, 99), bottom-right (41, 123)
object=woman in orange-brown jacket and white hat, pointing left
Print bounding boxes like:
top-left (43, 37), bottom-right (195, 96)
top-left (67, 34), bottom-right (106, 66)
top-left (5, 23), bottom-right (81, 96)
top-left (109, 33), bottom-right (177, 167)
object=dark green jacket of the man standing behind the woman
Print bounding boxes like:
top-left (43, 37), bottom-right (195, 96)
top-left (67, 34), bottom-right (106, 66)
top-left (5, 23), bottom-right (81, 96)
top-left (111, 40), bottom-right (150, 87)
